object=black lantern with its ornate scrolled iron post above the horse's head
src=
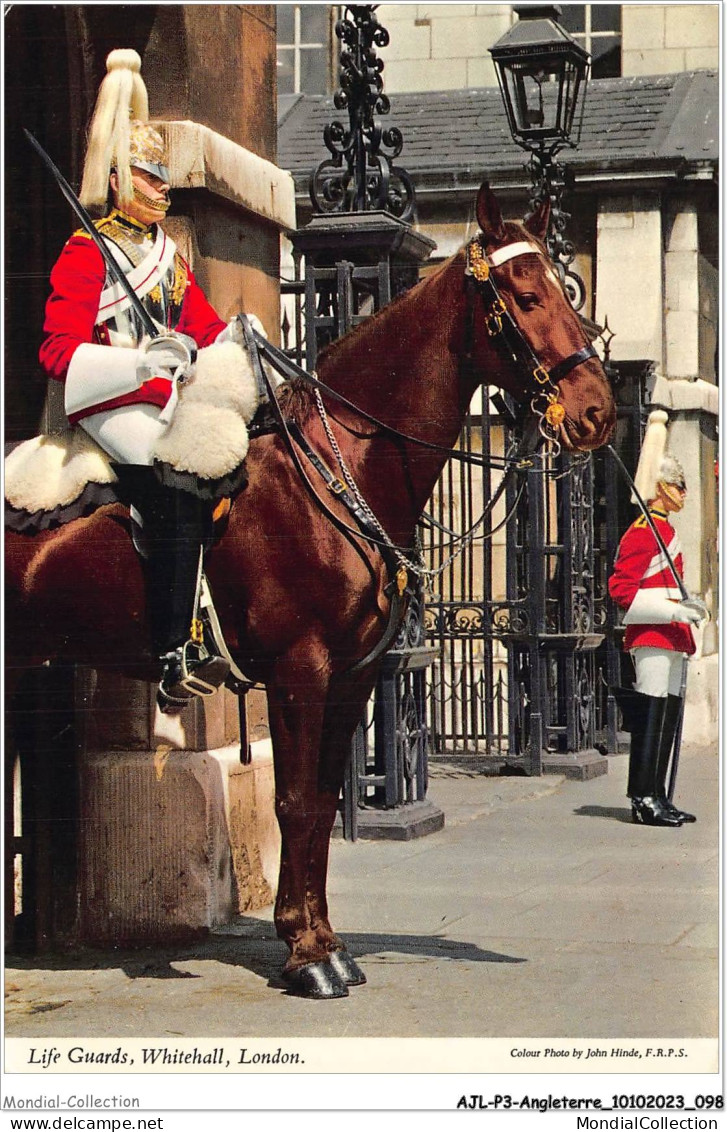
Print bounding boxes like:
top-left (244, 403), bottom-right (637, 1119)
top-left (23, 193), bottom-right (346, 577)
top-left (489, 5), bottom-right (591, 310)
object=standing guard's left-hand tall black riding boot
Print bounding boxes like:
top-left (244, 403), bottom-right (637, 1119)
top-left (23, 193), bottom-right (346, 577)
top-left (626, 693), bottom-right (682, 825)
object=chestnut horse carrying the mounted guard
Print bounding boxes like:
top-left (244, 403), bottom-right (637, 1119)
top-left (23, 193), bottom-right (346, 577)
top-left (6, 185), bottom-right (615, 997)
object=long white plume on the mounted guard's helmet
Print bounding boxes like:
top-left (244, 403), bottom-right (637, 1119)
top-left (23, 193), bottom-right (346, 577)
top-left (79, 50), bottom-right (149, 208)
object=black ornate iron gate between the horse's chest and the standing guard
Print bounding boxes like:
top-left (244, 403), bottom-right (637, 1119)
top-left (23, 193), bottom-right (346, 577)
top-left (425, 361), bottom-right (650, 777)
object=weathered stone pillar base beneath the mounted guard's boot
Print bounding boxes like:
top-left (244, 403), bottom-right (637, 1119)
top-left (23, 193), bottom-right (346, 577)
top-left (76, 669), bottom-right (279, 945)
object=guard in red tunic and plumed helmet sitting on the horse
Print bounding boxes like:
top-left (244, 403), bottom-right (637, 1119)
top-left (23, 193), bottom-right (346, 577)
top-left (40, 51), bottom-right (254, 712)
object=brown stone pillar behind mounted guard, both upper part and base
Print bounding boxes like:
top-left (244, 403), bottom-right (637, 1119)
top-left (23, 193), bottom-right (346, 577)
top-left (68, 5), bottom-right (296, 944)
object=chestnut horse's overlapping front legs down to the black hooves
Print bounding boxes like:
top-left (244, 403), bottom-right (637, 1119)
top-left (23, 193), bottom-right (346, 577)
top-left (267, 650), bottom-right (348, 998)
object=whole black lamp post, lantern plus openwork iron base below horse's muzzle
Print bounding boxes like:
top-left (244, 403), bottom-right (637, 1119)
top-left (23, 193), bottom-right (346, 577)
top-left (490, 5), bottom-right (607, 778)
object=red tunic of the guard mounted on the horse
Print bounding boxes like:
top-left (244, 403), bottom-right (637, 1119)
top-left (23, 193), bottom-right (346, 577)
top-left (40, 212), bottom-right (225, 423)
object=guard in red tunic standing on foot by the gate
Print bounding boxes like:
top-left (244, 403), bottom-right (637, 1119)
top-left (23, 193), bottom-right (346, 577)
top-left (608, 432), bottom-right (707, 826)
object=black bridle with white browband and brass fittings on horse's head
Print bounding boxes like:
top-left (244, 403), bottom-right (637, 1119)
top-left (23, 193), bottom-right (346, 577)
top-left (464, 235), bottom-right (597, 445)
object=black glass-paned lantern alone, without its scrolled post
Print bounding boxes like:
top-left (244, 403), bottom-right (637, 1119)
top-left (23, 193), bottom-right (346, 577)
top-left (489, 5), bottom-right (591, 155)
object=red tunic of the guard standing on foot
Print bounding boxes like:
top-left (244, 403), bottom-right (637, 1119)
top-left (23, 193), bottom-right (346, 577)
top-left (608, 507), bottom-right (695, 655)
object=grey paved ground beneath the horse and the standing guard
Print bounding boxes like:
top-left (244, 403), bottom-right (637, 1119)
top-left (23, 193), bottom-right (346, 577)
top-left (6, 746), bottom-right (719, 1038)
